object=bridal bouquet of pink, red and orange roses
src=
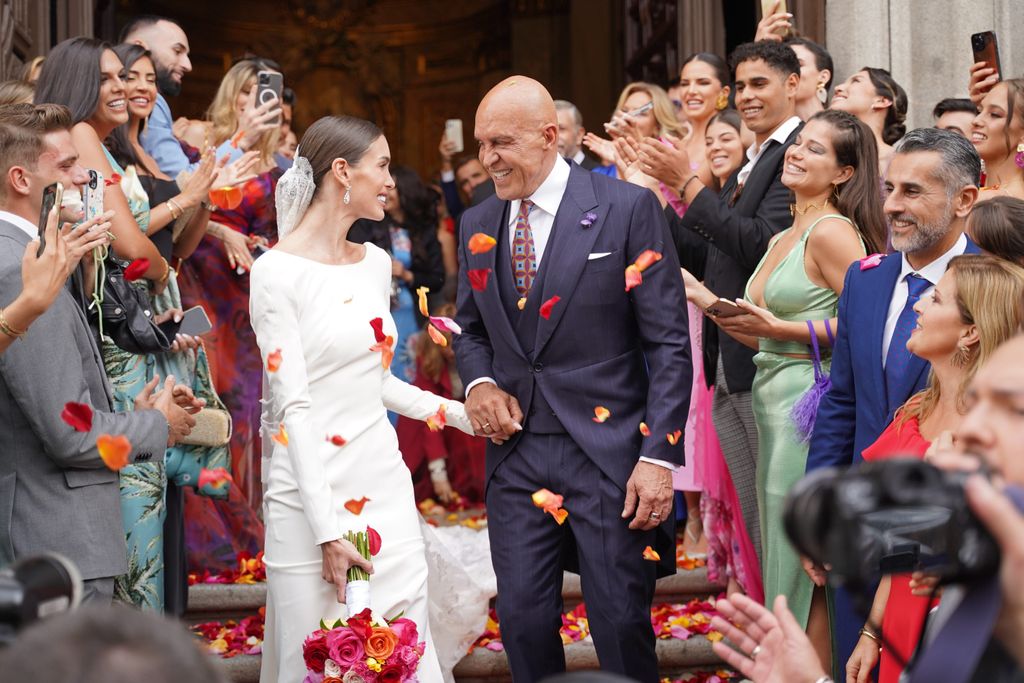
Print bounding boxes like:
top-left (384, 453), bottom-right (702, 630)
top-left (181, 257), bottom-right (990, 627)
top-left (302, 607), bottom-right (427, 683)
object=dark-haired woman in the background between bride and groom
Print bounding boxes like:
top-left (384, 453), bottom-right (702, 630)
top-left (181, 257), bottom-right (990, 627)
top-left (349, 166), bottom-right (444, 393)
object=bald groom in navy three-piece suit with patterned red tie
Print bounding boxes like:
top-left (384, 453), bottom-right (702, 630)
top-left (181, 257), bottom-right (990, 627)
top-left (455, 76), bottom-right (691, 683)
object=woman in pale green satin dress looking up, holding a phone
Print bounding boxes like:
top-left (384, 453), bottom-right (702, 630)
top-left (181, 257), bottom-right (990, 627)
top-left (684, 112), bottom-right (887, 663)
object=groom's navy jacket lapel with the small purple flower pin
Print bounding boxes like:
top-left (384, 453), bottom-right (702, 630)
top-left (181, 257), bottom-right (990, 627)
top-left (534, 164), bottom-right (604, 358)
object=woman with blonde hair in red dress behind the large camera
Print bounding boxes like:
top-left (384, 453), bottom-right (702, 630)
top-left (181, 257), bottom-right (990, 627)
top-left (846, 255), bottom-right (1024, 683)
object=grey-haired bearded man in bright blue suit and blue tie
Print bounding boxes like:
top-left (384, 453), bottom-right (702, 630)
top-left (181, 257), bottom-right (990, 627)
top-left (807, 128), bottom-right (981, 678)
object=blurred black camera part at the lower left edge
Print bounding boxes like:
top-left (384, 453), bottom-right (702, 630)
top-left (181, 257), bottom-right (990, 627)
top-left (0, 553), bottom-right (82, 646)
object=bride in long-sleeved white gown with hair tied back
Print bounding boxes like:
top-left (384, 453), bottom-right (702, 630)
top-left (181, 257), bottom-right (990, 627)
top-left (250, 117), bottom-right (472, 683)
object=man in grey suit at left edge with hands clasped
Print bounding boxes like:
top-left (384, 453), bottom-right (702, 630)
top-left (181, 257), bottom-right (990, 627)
top-left (0, 104), bottom-right (201, 602)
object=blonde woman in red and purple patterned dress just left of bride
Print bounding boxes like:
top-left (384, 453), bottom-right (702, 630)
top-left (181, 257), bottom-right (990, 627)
top-left (179, 59), bottom-right (282, 507)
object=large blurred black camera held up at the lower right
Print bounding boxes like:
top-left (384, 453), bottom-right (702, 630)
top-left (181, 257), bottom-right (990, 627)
top-left (783, 458), bottom-right (999, 588)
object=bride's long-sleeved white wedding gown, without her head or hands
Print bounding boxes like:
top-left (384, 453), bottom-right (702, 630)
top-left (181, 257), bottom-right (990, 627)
top-left (250, 244), bottom-right (472, 683)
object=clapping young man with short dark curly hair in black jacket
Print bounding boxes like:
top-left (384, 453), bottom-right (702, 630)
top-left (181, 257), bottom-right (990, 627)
top-left (640, 41), bottom-right (801, 557)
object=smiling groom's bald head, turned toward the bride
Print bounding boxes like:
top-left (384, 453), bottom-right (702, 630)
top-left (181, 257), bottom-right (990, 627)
top-left (474, 76), bottom-right (558, 200)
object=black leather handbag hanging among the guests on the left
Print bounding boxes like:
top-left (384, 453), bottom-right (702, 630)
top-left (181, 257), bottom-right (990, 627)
top-left (99, 255), bottom-right (173, 353)
